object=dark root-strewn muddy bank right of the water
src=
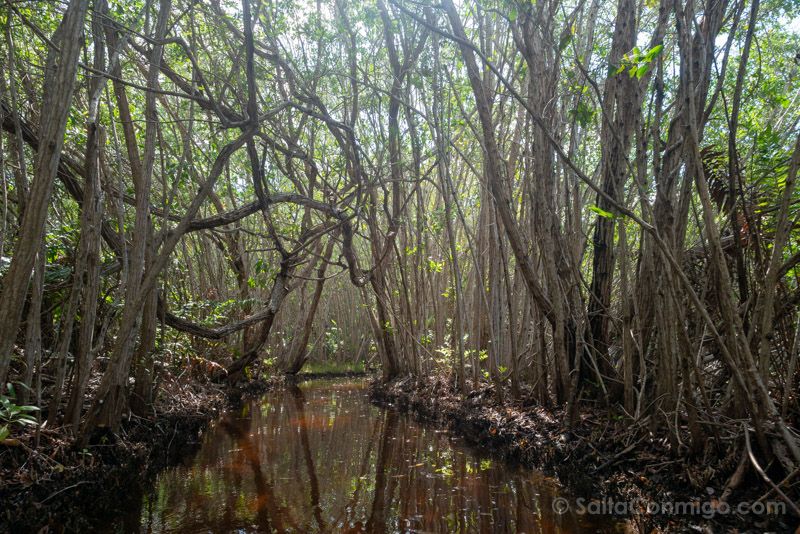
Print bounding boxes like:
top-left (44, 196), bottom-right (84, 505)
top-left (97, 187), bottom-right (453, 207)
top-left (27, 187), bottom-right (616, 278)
top-left (370, 378), bottom-right (798, 533)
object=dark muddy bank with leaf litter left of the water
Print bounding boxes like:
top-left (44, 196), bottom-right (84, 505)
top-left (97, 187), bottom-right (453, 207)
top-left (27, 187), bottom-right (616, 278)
top-left (0, 384), bottom-right (228, 532)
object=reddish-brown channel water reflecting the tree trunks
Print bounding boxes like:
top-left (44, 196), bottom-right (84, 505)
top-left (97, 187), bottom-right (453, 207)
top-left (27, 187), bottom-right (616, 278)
top-left (130, 379), bottom-right (610, 533)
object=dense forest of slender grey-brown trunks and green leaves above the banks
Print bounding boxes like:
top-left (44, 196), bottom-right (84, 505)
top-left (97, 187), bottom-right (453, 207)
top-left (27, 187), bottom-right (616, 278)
top-left (0, 0), bottom-right (800, 516)
